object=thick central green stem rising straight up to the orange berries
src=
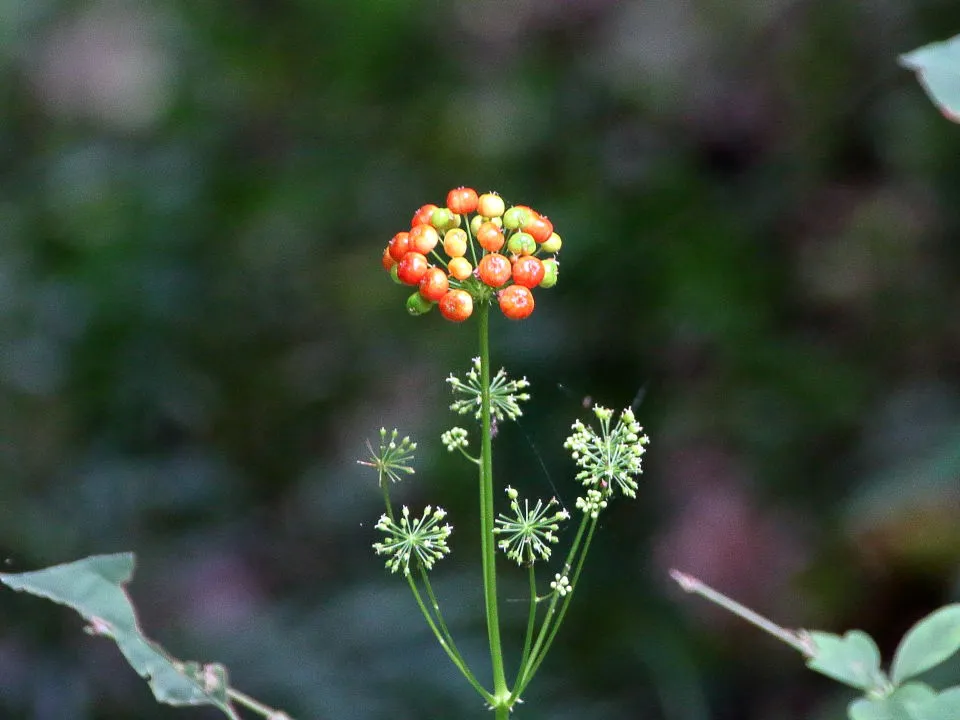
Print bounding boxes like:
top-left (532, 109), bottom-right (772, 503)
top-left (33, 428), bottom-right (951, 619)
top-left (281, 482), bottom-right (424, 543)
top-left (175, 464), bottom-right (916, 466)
top-left (479, 303), bottom-right (510, 720)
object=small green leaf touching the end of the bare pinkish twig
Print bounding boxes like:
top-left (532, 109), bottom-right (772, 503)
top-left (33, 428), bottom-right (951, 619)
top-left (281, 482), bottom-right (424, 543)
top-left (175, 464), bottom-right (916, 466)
top-left (807, 630), bottom-right (889, 691)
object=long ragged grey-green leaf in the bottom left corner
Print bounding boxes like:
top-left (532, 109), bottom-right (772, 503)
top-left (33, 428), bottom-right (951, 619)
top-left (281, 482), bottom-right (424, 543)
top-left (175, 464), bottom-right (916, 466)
top-left (0, 553), bottom-right (237, 718)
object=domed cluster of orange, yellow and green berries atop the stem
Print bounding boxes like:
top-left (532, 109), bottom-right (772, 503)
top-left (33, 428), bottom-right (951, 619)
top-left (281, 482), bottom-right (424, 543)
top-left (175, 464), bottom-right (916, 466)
top-left (383, 187), bottom-right (562, 322)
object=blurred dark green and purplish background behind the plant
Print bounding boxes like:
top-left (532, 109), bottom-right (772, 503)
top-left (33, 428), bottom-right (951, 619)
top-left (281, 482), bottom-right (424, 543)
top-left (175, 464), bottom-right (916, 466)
top-left (0, 0), bottom-right (960, 720)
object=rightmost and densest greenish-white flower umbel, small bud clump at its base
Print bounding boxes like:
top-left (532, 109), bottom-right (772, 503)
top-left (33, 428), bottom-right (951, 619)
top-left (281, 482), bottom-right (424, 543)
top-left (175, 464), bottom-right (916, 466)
top-left (563, 406), bottom-right (650, 504)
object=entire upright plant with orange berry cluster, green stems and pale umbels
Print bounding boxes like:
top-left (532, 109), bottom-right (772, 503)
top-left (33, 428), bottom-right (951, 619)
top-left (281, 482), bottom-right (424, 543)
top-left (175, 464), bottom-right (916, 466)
top-left (362, 188), bottom-right (647, 720)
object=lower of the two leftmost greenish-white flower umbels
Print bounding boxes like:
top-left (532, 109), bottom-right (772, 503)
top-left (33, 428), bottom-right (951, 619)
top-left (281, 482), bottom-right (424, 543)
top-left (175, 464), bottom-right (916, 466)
top-left (373, 505), bottom-right (453, 575)
